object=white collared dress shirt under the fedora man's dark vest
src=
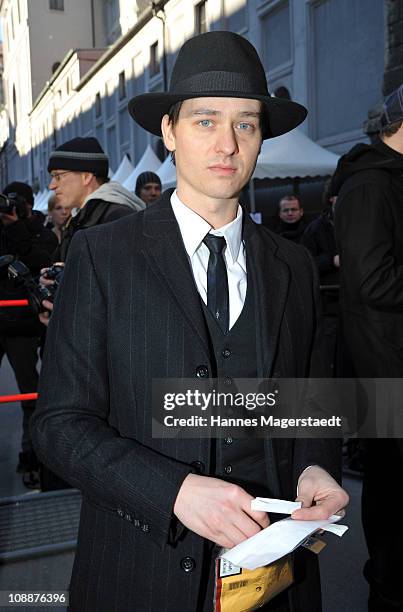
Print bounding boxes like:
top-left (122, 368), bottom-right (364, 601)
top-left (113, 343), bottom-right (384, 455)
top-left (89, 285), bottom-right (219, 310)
top-left (171, 190), bottom-right (246, 329)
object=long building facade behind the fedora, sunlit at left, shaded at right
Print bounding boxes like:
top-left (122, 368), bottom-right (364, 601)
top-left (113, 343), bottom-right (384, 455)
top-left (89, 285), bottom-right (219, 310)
top-left (0, 0), bottom-right (386, 189)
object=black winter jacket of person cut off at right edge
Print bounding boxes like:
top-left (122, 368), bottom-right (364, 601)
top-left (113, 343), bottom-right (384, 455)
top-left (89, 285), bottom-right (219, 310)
top-left (333, 141), bottom-right (403, 378)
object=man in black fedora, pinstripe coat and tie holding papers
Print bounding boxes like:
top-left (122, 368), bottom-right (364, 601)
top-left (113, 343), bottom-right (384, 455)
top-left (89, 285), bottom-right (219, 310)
top-left (34, 32), bottom-right (348, 612)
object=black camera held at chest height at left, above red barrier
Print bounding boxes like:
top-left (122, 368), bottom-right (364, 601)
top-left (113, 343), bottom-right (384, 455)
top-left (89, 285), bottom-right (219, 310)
top-left (8, 260), bottom-right (63, 314)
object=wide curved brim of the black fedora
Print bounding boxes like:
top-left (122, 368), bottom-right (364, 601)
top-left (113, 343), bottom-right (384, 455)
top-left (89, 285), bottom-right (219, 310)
top-left (128, 91), bottom-right (308, 140)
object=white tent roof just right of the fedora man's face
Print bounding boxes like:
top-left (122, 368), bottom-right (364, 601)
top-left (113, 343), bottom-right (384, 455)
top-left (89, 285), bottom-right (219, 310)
top-left (252, 128), bottom-right (339, 179)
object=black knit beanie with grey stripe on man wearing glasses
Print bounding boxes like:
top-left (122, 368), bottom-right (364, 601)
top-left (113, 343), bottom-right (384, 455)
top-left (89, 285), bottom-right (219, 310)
top-left (48, 137), bottom-right (109, 177)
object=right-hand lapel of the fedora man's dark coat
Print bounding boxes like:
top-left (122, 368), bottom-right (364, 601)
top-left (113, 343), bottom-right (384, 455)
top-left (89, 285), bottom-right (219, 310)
top-left (244, 213), bottom-right (290, 377)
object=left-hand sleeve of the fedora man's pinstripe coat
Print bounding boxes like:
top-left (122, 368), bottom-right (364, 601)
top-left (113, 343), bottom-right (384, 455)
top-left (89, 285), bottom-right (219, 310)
top-left (31, 231), bottom-right (192, 548)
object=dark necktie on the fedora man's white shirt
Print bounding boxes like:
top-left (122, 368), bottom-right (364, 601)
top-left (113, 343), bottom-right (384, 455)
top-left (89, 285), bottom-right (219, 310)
top-left (203, 234), bottom-right (229, 334)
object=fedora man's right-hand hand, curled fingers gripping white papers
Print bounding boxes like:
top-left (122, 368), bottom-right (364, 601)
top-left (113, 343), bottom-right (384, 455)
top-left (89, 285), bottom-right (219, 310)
top-left (291, 465), bottom-right (349, 521)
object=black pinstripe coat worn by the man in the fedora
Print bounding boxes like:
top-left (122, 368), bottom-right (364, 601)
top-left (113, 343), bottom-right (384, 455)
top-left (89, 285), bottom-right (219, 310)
top-left (33, 193), bottom-right (339, 612)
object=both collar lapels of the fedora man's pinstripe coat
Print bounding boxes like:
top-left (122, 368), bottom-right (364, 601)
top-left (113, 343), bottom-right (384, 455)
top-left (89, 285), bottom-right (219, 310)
top-left (143, 190), bottom-right (290, 376)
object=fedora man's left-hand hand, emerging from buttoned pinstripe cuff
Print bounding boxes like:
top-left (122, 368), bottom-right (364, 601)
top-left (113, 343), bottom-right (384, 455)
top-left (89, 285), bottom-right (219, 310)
top-left (174, 474), bottom-right (270, 548)
